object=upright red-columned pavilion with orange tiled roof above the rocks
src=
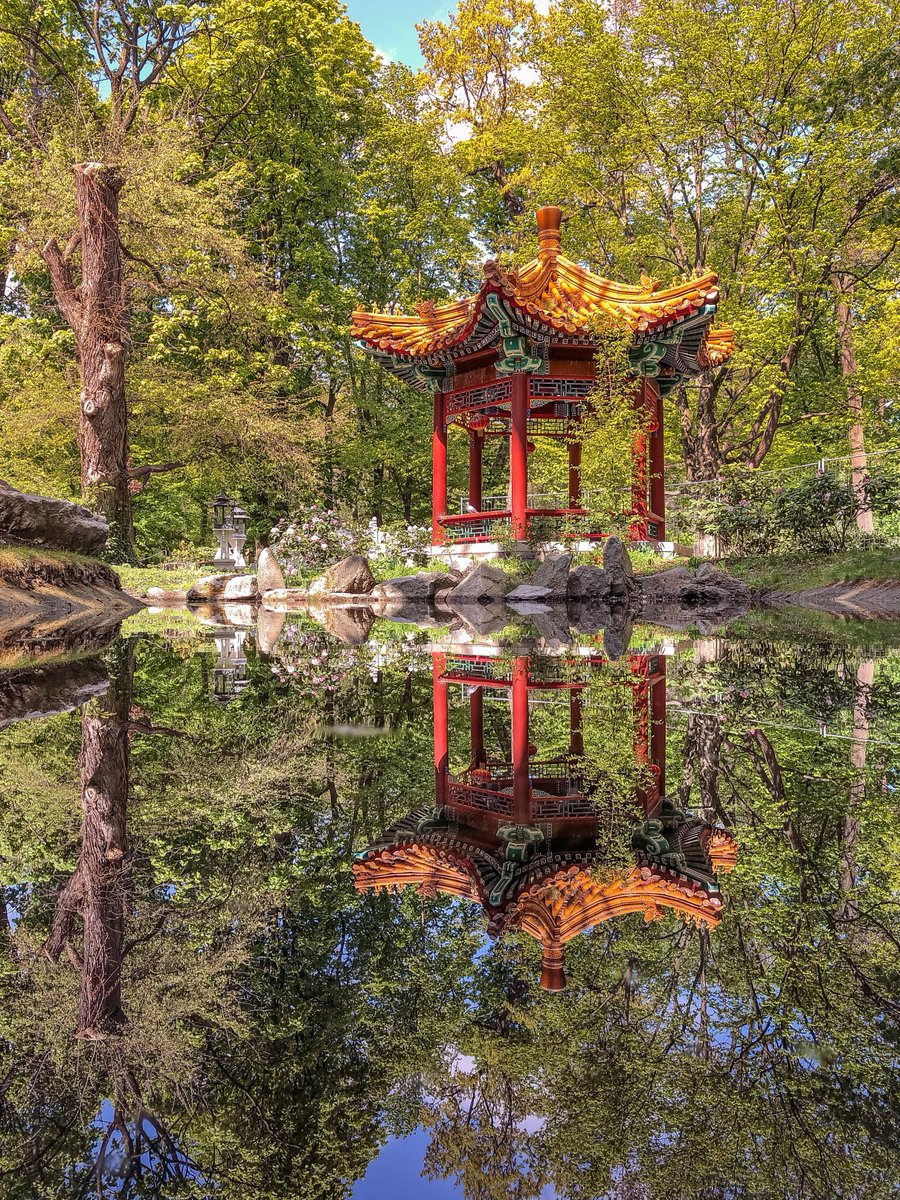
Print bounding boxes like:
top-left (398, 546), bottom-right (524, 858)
top-left (353, 205), bottom-right (734, 546)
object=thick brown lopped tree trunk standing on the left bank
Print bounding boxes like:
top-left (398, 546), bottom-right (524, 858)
top-left (43, 162), bottom-right (134, 557)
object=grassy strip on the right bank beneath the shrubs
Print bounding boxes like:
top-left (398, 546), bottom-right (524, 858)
top-left (716, 547), bottom-right (900, 592)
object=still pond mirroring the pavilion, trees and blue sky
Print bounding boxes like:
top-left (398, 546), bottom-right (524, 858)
top-left (0, 612), bottom-right (900, 1200)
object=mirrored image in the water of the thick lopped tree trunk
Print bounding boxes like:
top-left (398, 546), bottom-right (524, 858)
top-left (44, 644), bottom-right (134, 1038)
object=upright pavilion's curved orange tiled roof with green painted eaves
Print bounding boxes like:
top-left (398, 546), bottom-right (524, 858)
top-left (352, 205), bottom-right (734, 391)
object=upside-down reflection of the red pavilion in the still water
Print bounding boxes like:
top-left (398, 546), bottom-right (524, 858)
top-left (354, 653), bottom-right (737, 991)
